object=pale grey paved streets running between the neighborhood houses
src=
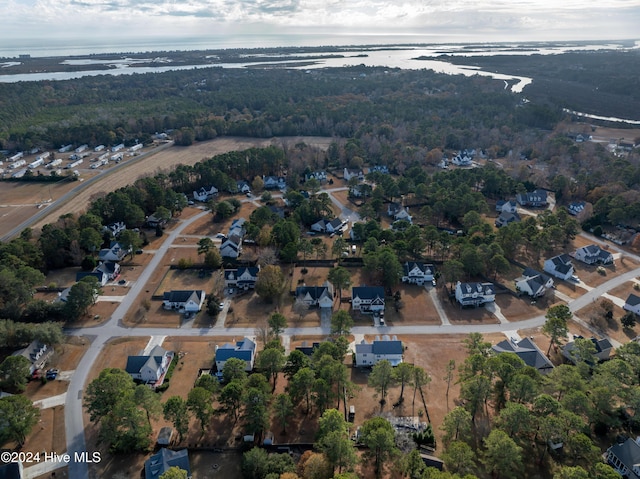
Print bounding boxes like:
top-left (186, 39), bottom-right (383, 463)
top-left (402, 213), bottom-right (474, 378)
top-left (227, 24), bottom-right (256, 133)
top-left (25, 188), bottom-right (640, 479)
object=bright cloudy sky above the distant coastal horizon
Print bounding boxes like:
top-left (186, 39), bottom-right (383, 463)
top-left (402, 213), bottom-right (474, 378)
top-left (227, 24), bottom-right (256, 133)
top-left (0, 0), bottom-right (640, 46)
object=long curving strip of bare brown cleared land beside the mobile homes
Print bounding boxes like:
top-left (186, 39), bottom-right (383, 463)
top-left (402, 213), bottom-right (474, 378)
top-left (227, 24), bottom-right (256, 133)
top-left (0, 137), bottom-right (333, 240)
